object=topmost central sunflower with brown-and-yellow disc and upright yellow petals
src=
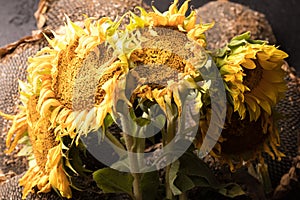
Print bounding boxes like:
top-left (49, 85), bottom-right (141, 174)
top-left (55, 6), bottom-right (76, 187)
top-left (105, 0), bottom-right (214, 114)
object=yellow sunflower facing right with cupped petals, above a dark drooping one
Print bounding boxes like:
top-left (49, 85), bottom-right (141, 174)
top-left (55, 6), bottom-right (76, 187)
top-left (215, 32), bottom-right (288, 121)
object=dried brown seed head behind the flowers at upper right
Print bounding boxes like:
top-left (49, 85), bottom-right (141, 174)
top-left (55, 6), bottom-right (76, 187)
top-left (197, 1), bottom-right (276, 49)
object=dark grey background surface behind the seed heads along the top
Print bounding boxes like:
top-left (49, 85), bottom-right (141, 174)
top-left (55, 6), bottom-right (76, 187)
top-left (0, 0), bottom-right (300, 74)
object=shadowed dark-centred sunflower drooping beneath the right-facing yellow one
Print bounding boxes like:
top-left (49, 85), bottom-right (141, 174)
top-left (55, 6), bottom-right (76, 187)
top-left (212, 109), bottom-right (285, 171)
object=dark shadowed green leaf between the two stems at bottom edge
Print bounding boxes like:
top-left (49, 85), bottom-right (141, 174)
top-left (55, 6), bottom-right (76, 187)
top-left (141, 171), bottom-right (160, 200)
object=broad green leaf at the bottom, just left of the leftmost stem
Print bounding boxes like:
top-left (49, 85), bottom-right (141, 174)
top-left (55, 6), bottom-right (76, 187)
top-left (93, 168), bottom-right (133, 196)
